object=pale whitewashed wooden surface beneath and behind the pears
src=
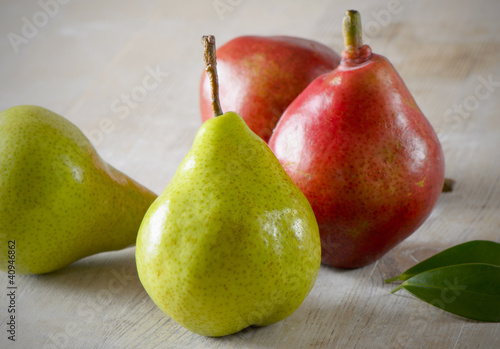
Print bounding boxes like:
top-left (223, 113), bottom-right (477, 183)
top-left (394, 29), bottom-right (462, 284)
top-left (0, 0), bottom-right (500, 349)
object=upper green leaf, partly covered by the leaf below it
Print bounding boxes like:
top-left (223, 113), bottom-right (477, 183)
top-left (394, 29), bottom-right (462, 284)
top-left (385, 240), bottom-right (500, 283)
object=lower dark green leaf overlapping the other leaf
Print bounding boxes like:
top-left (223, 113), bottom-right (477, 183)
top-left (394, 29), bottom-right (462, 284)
top-left (392, 263), bottom-right (500, 322)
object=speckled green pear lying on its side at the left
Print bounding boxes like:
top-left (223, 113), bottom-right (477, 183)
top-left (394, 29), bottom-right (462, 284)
top-left (0, 106), bottom-right (156, 274)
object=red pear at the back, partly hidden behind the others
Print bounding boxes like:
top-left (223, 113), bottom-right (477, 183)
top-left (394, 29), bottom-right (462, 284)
top-left (200, 36), bottom-right (340, 142)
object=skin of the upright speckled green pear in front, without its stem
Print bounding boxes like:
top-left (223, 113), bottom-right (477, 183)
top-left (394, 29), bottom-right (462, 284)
top-left (136, 112), bottom-right (321, 337)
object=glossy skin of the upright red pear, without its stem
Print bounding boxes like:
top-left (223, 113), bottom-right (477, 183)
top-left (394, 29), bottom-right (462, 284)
top-left (269, 48), bottom-right (444, 268)
